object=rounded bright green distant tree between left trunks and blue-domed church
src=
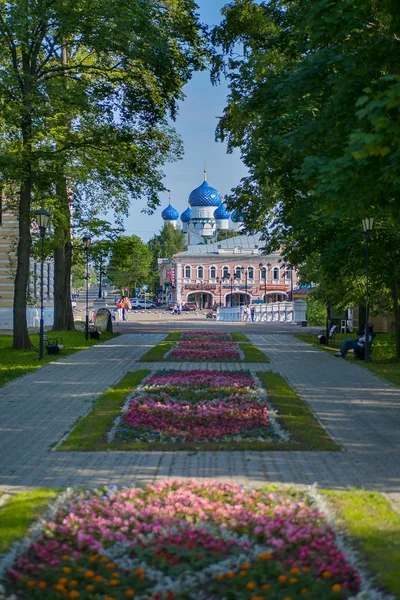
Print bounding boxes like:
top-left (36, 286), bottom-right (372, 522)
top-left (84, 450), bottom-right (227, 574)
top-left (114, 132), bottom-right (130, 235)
top-left (107, 235), bottom-right (153, 292)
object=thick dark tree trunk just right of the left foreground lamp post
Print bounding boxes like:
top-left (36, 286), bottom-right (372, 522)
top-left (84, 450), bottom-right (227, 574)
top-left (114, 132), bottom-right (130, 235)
top-left (53, 183), bottom-right (75, 331)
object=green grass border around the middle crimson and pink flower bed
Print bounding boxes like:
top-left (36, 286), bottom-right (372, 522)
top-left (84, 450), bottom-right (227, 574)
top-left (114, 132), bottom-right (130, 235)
top-left (57, 370), bottom-right (340, 452)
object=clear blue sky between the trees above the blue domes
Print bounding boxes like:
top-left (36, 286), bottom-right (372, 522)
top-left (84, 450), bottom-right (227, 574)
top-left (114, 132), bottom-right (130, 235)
top-left (120, 0), bottom-right (246, 241)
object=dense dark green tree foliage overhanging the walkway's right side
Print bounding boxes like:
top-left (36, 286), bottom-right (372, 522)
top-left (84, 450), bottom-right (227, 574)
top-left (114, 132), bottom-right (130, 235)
top-left (213, 0), bottom-right (400, 356)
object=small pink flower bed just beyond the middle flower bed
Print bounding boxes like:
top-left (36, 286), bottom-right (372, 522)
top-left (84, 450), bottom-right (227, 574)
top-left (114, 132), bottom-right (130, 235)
top-left (168, 340), bottom-right (241, 360)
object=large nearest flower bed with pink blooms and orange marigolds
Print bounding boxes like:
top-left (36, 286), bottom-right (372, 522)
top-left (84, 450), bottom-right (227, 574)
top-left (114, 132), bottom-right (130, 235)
top-left (5, 480), bottom-right (360, 600)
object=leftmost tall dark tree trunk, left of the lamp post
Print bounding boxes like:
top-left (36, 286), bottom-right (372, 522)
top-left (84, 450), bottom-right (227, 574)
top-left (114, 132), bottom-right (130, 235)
top-left (12, 175), bottom-right (33, 350)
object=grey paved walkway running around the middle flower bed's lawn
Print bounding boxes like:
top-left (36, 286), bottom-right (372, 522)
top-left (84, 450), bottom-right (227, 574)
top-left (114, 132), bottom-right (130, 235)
top-left (0, 334), bottom-right (400, 507)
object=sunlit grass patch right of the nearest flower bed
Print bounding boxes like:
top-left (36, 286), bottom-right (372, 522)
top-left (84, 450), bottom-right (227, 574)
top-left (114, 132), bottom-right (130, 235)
top-left (322, 489), bottom-right (400, 598)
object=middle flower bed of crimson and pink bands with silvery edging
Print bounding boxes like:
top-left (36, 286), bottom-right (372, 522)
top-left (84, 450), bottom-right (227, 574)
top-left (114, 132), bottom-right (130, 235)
top-left (110, 370), bottom-right (277, 442)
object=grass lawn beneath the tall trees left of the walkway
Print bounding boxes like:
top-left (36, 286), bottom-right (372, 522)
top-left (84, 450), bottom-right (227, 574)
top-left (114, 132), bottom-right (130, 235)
top-left (0, 331), bottom-right (119, 386)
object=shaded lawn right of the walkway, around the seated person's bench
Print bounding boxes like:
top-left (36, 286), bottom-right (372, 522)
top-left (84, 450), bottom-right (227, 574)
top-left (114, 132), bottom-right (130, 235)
top-left (297, 333), bottom-right (400, 387)
